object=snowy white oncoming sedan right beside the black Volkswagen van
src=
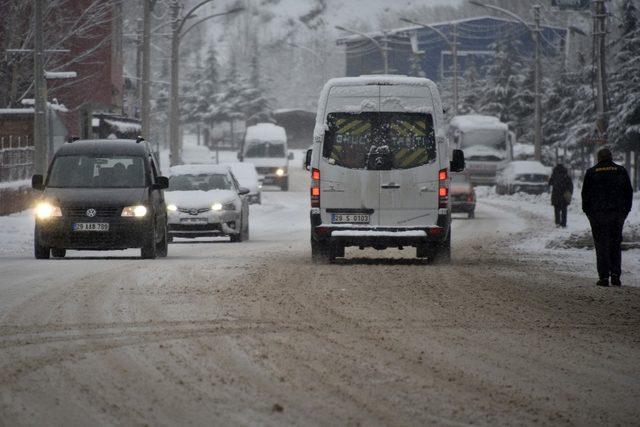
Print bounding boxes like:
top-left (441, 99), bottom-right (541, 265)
top-left (165, 164), bottom-right (249, 242)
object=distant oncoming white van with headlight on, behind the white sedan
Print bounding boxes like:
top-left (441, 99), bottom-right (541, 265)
top-left (238, 123), bottom-right (293, 191)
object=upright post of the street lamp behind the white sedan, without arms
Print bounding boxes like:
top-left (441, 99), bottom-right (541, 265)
top-left (169, 0), bottom-right (182, 166)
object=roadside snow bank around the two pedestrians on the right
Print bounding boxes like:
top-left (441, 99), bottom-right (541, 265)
top-left (476, 187), bottom-right (640, 286)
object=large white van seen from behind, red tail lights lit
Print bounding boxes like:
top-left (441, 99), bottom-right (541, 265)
top-left (307, 76), bottom-right (464, 262)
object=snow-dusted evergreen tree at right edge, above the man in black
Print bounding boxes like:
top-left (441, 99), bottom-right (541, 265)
top-left (609, 0), bottom-right (640, 150)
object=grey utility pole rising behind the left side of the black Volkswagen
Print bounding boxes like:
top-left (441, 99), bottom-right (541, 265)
top-left (33, 0), bottom-right (49, 175)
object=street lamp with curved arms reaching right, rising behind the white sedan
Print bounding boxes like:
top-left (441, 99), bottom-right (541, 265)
top-left (169, 0), bottom-right (244, 166)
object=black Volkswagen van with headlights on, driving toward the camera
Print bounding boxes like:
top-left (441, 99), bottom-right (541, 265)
top-left (31, 139), bottom-right (169, 259)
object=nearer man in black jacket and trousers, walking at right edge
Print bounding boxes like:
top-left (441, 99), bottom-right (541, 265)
top-left (582, 148), bottom-right (633, 286)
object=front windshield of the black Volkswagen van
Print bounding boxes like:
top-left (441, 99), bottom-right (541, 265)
top-left (47, 155), bottom-right (146, 188)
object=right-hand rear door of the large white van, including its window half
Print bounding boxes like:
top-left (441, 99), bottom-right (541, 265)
top-left (379, 85), bottom-right (439, 227)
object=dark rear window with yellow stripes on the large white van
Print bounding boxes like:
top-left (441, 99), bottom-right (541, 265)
top-left (322, 112), bottom-right (436, 169)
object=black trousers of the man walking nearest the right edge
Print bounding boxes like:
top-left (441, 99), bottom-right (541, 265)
top-left (589, 217), bottom-right (624, 279)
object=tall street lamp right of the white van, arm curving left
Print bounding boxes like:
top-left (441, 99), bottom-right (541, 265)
top-left (469, 0), bottom-right (542, 161)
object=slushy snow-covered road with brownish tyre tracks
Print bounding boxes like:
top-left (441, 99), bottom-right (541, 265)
top-left (0, 167), bottom-right (640, 425)
